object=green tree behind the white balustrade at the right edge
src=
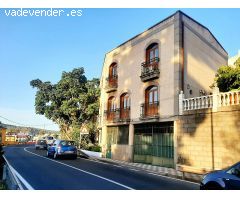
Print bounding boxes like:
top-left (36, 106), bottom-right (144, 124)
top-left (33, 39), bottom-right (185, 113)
top-left (212, 58), bottom-right (240, 92)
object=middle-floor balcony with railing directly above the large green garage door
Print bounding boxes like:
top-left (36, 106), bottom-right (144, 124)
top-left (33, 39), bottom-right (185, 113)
top-left (140, 101), bottom-right (159, 120)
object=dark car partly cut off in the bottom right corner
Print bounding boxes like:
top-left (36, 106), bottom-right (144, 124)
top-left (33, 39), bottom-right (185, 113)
top-left (200, 162), bottom-right (240, 190)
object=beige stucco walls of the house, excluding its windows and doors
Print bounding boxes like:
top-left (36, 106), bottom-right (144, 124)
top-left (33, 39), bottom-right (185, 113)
top-left (99, 11), bottom-right (228, 168)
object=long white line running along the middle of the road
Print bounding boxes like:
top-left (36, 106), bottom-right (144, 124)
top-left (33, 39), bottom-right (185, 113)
top-left (24, 147), bottom-right (134, 190)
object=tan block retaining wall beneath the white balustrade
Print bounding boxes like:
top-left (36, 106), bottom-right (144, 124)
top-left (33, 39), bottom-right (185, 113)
top-left (175, 105), bottom-right (240, 173)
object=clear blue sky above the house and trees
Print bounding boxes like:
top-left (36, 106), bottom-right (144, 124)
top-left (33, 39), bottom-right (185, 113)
top-left (0, 8), bottom-right (240, 130)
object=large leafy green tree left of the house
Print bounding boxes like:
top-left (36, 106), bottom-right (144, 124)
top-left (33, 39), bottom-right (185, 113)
top-left (30, 67), bottom-right (100, 139)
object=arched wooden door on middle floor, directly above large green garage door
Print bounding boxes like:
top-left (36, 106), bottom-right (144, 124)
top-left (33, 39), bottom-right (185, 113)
top-left (145, 86), bottom-right (159, 116)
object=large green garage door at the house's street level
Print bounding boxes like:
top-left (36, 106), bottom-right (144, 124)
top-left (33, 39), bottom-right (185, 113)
top-left (134, 122), bottom-right (174, 167)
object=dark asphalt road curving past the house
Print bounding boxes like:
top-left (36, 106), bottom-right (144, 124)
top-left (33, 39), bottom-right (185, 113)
top-left (4, 146), bottom-right (199, 190)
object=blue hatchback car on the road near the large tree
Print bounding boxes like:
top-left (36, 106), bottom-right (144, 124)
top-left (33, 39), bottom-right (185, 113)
top-left (47, 140), bottom-right (77, 159)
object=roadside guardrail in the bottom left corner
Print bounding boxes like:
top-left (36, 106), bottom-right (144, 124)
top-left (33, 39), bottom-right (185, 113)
top-left (3, 155), bottom-right (33, 190)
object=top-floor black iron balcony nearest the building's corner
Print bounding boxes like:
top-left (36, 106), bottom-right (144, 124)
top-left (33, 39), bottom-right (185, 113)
top-left (140, 57), bottom-right (160, 82)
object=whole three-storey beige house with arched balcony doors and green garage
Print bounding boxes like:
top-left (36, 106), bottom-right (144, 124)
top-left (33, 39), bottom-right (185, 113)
top-left (99, 11), bottom-right (228, 167)
